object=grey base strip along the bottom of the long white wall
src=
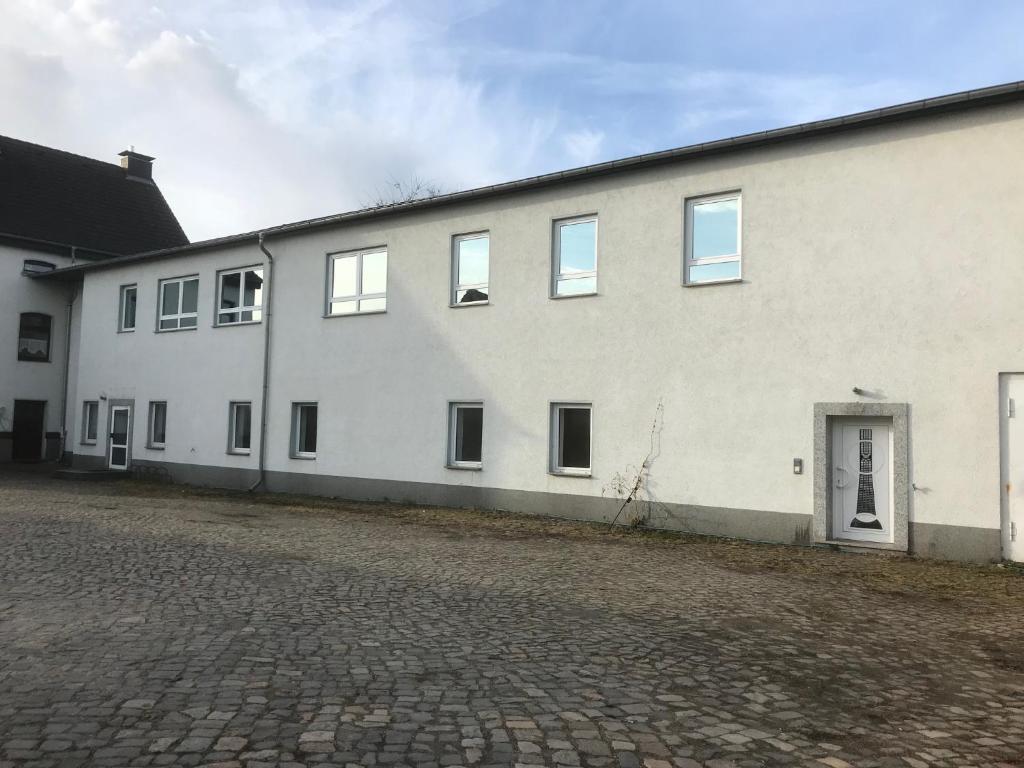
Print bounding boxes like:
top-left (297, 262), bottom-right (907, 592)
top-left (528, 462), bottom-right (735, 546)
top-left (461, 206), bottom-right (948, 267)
top-left (74, 456), bottom-right (1000, 562)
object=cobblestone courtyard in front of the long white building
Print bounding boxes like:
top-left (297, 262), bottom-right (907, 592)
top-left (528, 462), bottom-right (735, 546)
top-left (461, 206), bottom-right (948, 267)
top-left (0, 473), bottom-right (1024, 768)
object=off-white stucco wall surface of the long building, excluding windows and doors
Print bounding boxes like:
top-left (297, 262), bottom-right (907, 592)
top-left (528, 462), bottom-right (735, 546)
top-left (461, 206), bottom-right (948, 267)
top-left (68, 105), bottom-right (1024, 561)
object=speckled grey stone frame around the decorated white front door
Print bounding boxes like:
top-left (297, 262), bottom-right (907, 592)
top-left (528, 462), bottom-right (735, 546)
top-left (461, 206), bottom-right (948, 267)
top-left (813, 402), bottom-right (910, 552)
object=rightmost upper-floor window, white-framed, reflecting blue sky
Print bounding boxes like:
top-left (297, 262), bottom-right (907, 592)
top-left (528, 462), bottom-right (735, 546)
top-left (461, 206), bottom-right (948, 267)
top-left (683, 193), bottom-right (741, 285)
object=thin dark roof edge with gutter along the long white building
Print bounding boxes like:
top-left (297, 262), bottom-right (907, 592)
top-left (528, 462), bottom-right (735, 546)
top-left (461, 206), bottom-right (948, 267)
top-left (33, 80), bottom-right (1024, 280)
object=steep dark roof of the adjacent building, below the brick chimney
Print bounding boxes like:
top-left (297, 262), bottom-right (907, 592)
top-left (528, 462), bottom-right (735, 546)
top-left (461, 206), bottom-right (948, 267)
top-left (0, 136), bottom-right (188, 255)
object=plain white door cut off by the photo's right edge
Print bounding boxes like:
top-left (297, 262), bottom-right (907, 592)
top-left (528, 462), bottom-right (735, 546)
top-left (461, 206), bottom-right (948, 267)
top-left (999, 374), bottom-right (1024, 562)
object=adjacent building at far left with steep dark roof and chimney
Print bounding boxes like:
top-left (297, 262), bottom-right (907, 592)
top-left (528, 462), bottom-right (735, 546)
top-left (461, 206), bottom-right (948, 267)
top-left (0, 136), bottom-right (188, 462)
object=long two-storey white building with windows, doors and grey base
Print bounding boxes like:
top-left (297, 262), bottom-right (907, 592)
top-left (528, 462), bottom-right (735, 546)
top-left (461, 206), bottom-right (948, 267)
top-left (22, 83), bottom-right (1024, 560)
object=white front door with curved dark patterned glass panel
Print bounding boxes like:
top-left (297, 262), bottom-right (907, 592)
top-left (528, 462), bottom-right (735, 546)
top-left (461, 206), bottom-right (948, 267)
top-left (831, 419), bottom-right (893, 543)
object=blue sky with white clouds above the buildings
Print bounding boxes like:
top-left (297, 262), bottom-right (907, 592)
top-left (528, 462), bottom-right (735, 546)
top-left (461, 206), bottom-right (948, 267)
top-left (0, 0), bottom-right (1024, 241)
